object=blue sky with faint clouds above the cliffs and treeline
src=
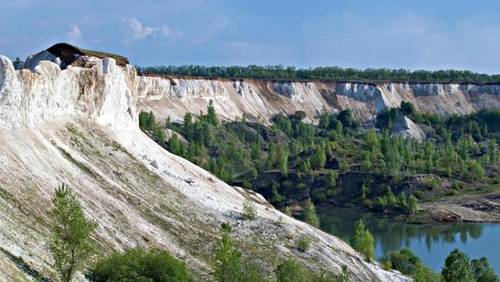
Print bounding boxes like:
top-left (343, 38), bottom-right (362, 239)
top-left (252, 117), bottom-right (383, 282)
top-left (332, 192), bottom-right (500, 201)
top-left (0, 0), bottom-right (500, 73)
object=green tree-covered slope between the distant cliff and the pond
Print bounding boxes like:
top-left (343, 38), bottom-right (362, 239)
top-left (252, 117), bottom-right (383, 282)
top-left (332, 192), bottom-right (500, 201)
top-left (140, 102), bottom-right (500, 221)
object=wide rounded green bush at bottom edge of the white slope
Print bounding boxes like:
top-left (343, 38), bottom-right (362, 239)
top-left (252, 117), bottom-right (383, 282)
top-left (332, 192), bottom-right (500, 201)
top-left (89, 248), bottom-right (194, 282)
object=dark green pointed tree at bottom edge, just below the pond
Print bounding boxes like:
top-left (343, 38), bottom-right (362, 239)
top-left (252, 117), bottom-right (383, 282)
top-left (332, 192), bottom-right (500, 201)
top-left (441, 249), bottom-right (475, 282)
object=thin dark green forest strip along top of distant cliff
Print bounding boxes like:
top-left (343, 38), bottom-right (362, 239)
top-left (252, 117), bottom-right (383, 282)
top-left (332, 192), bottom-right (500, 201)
top-left (137, 65), bottom-right (500, 84)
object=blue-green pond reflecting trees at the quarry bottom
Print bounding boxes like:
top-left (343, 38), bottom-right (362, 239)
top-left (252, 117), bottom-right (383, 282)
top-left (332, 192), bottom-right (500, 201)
top-left (317, 207), bottom-right (500, 274)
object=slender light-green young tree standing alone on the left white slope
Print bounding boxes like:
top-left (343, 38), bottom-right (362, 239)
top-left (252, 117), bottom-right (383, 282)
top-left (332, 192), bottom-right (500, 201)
top-left (49, 184), bottom-right (96, 282)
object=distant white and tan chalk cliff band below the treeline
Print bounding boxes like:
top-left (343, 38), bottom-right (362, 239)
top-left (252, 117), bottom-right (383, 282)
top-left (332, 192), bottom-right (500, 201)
top-left (136, 76), bottom-right (500, 124)
